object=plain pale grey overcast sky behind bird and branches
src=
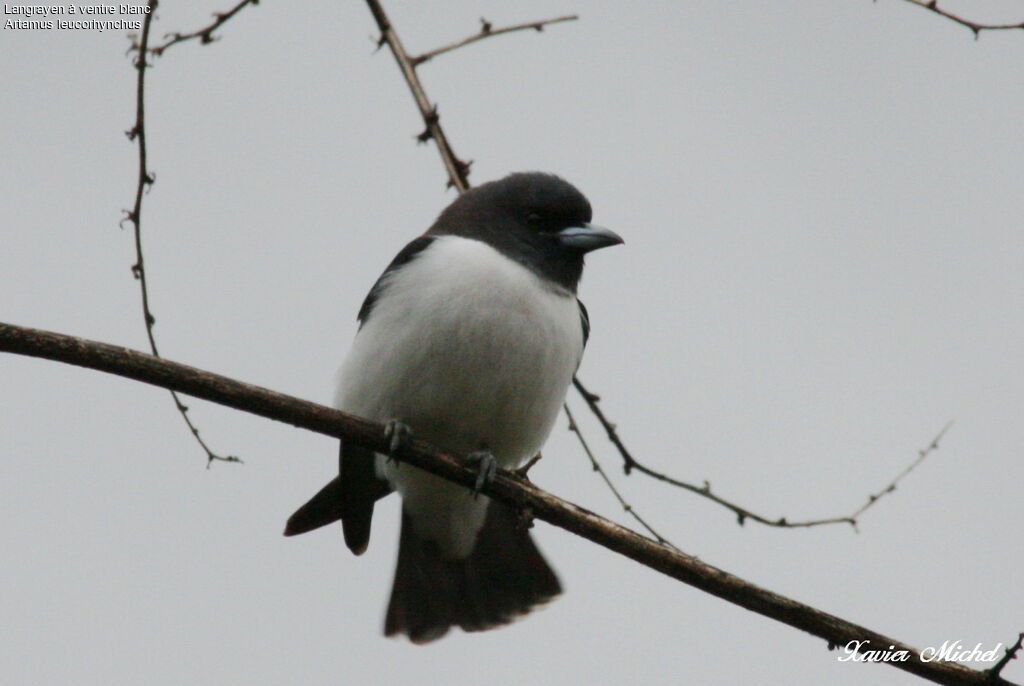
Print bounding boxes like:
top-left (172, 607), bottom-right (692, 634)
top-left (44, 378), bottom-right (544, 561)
top-left (0, 0), bottom-right (1024, 686)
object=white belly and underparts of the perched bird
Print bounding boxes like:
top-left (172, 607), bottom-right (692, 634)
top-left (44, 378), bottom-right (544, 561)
top-left (337, 237), bottom-right (583, 555)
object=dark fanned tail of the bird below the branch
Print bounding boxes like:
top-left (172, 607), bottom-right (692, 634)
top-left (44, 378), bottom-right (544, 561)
top-left (384, 501), bottom-right (562, 643)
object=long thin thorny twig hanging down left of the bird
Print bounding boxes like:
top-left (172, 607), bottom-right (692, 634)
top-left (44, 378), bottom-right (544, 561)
top-left (121, 0), bottom-right (242, 468)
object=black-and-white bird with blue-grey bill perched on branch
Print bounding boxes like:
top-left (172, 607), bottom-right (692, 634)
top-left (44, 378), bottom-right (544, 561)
top-left (285, 172), bottom-right (623, 644)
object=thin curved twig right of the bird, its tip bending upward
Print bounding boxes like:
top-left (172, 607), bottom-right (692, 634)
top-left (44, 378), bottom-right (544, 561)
top-left (572, 379), bottom-right (952, 529)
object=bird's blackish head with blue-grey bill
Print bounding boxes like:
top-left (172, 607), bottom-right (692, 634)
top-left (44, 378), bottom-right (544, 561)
top-left (428, 172), bottom-right (623, 292)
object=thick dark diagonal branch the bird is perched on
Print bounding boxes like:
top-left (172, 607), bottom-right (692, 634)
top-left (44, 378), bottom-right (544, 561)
top-left (0, 324), bottom-right (1013, 686)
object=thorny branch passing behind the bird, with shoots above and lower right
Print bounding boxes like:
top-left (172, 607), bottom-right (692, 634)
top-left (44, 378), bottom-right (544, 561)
top-left (367, 0), bottom-right (951, 543)
